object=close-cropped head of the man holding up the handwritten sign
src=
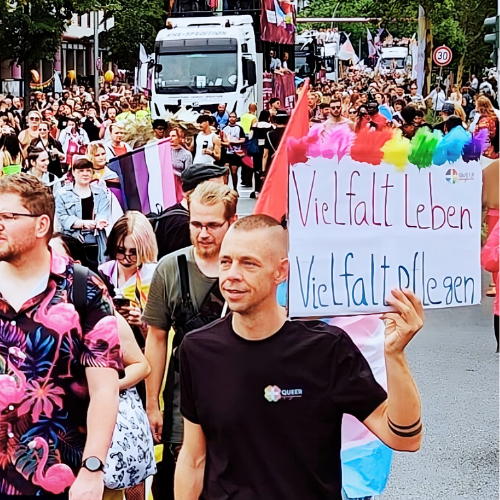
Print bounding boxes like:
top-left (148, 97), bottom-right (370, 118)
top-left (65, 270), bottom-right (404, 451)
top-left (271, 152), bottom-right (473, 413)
top-left (219, 215), bottom-right (288, 315)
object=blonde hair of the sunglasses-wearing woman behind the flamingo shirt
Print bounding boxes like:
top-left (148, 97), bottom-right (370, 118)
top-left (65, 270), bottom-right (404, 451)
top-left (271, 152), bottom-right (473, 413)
top-left (106, 210), bottom-right (158, 267)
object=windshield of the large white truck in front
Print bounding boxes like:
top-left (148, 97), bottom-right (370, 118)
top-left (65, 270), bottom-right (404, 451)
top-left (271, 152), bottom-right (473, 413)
top-left (156, 51), bottom-right (238, 94)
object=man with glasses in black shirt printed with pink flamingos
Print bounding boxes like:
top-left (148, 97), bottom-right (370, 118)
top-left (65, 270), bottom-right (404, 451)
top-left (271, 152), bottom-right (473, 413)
top-left (0, 174), bottom-right (123, 500)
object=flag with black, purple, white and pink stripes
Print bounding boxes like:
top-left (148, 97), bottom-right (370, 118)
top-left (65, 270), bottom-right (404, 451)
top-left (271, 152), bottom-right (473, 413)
top-left (108, 139), bottom-right (177, 215)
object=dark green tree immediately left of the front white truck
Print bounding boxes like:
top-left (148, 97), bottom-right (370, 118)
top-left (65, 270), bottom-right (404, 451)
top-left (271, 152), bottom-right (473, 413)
top-left (101, 0), bottom-right (166, 70)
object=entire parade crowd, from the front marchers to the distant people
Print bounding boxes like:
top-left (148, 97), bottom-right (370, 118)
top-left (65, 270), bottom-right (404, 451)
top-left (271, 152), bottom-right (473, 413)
top-left (0, 63), bottom-right (499, 500)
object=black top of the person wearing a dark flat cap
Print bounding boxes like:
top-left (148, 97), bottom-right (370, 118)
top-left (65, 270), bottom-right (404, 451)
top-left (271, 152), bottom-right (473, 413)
top-left (155, 203), bottom-right (191, 260)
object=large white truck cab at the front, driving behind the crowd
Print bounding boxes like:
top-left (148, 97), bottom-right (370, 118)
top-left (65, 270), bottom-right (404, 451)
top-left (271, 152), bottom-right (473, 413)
top-left (151, 15), bottom-right (263, 118)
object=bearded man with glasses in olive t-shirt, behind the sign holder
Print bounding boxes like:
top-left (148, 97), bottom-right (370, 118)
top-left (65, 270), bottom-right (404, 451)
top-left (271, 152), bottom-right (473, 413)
top-left (143, 181), bottom-right (238, 499)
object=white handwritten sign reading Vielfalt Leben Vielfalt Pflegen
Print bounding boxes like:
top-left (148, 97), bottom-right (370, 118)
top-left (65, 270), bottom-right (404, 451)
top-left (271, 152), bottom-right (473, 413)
top-left (289, 157), bottom-right (481, 317)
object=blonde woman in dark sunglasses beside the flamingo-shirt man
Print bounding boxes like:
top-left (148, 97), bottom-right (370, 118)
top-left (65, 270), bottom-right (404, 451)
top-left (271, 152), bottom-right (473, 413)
top-left (99, 210), bottom-right (158, 348)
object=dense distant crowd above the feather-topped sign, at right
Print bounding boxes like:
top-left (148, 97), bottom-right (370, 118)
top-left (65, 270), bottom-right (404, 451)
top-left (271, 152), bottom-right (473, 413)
top-left (308, 70), bottom-right (500, 159)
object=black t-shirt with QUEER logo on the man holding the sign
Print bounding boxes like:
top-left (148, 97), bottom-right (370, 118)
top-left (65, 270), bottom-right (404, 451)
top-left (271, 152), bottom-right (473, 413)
top-left (180, 315), bottom-right (387, 500)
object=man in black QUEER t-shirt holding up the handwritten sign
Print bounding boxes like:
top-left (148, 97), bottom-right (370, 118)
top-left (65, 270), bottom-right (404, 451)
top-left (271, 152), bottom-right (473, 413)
top-left (175, 215), bottom-right (423, 500)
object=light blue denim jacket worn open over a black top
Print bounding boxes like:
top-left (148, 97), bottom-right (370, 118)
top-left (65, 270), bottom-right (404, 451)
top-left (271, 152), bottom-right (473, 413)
top-left (56, 184), bottom-right (111, 263)
